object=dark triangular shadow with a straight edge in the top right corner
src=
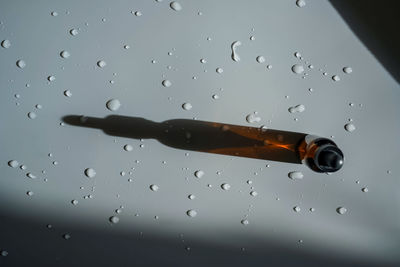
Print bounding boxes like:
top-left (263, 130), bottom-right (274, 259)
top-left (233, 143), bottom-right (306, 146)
top-left (330, 0), bottom-right (400, 82)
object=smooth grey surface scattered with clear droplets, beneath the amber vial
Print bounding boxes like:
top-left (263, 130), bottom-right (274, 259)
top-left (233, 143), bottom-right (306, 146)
top-left (0, 0), bottom-right (400, 266)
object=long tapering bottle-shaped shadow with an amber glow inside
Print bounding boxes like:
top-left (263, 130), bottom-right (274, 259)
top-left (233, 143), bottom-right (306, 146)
top-left (62, 115), bottom-right (306, 164)
